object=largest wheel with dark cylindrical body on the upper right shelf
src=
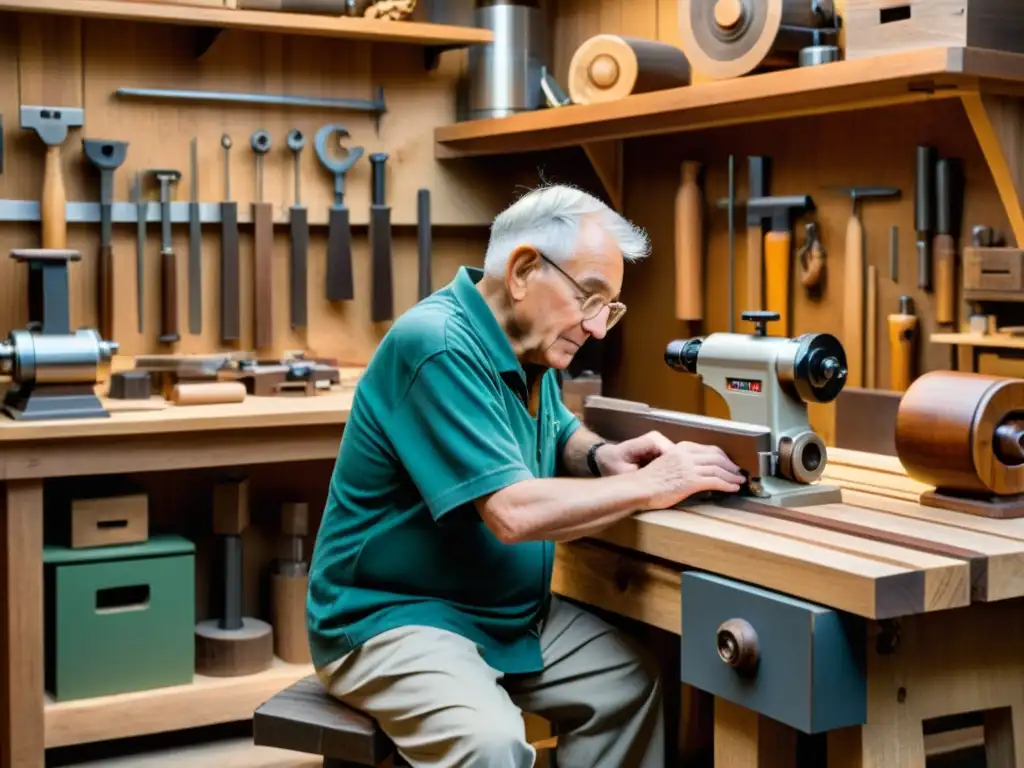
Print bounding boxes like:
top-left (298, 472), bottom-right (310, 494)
top-left (679, 0), bottom-right (835, 80)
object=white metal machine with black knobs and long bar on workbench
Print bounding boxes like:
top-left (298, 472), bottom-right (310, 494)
top-left (584, 311), bottom-right (847, 507)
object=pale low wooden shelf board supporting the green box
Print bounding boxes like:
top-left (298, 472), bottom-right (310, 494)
top-left (45, 659), bottom-right (313, 748)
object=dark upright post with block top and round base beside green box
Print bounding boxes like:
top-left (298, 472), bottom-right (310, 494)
top-left (196, 480), bottom-right (273, 677)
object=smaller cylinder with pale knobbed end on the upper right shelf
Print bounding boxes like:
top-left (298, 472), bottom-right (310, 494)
top-left (568, 35), bottom-right (690, 104)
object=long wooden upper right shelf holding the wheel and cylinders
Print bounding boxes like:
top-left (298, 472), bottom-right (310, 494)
top-left (434, 47), bottom-right (1024, 158)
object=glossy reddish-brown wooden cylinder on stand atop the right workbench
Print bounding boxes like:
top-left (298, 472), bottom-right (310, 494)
top-left (895, 371), bottom-right (1024, 517)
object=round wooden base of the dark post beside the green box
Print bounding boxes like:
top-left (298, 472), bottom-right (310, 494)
top-left (196, 616), bottom-right (273, 677)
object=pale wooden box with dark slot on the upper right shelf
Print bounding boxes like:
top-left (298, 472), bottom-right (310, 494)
top-left (844, 0), bottom-right (1024, 59)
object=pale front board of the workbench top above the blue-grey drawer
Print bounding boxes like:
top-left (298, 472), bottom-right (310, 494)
top-left (595, 509), bottom-right (927, 618)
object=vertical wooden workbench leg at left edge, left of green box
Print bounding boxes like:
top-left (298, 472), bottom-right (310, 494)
top-left (0, 479), bottom-right (46, 768)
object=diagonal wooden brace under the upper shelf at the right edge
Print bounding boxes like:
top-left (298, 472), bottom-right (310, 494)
top-left (961, 91), bottom-right (1024, 248)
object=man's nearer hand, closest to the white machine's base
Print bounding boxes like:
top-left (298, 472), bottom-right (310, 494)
top-left (630, 442), bottom-right (746, 509)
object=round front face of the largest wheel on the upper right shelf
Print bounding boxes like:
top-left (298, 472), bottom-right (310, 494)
top-left (679, 0), bottom-right (784, 80)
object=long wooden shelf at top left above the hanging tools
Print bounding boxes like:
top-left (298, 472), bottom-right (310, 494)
top-left (0, 0), bottom-right (494, 48)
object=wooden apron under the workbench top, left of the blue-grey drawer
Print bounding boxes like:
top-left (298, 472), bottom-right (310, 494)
top-left (551, 542), bottom-right (682, 635)
